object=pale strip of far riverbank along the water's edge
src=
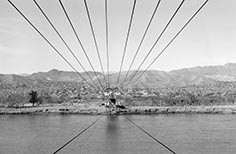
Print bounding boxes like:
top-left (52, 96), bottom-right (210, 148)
top-left (0, 104), bottom-right (236, 115)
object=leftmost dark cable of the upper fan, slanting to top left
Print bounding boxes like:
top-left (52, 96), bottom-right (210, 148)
top-left (8, 0), bottom-right (93, 87)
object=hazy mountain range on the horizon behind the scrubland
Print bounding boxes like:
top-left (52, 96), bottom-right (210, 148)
top-left (0, 63), bottom-right (236, 88)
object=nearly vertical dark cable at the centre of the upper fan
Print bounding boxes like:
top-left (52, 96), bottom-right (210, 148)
top-left (105, 0), bottom-right (110, 87)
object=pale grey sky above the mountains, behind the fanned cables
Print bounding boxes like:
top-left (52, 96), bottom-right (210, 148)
top-left (0, 0), bottom-right (236, 74)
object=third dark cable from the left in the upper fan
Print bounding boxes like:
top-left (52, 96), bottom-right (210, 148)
top-left (59, 0), bottom-right (103, 88)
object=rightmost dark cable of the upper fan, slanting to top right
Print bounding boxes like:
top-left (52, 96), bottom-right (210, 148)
top-left (133, 0), bottom-right (208, 84)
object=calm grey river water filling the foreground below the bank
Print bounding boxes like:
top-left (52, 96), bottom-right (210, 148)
top-left (0, 114), bottom-right (236, 154)
